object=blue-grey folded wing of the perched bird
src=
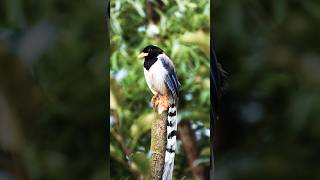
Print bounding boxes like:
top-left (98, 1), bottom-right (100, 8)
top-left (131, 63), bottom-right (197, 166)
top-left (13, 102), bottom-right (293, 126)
top-left (158, 54), bottom-right (181, 97)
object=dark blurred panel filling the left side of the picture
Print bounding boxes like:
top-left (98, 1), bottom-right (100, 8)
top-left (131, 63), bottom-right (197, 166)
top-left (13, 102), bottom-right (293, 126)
top-left (0, 0), bottom-right (109, 180)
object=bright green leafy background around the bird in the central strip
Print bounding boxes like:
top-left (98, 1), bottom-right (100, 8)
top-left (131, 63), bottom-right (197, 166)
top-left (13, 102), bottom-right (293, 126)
top-left (110, 0), bottom-right (210, 180)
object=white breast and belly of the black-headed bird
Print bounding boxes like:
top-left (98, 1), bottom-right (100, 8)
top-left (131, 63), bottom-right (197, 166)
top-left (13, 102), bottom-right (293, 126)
top-left (144, 60), bottom-right (168, 95)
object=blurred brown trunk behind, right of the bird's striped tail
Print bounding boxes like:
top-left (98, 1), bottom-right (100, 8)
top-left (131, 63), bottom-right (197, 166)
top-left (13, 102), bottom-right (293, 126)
top-left (178, 121), bottom-right (206, 180)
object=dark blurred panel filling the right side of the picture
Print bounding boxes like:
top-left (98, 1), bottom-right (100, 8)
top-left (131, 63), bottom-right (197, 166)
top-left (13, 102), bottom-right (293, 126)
top-left (211, 0), bottom-right (320, 180)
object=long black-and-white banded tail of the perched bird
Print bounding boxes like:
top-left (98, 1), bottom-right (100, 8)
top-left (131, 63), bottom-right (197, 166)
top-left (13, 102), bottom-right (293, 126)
top-left (162, 98), bottom-right (177, 180)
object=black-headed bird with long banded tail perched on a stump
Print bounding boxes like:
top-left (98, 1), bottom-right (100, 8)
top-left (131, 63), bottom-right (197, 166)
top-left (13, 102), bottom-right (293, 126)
top-left (138, 45), bottom-right (181, 180)
